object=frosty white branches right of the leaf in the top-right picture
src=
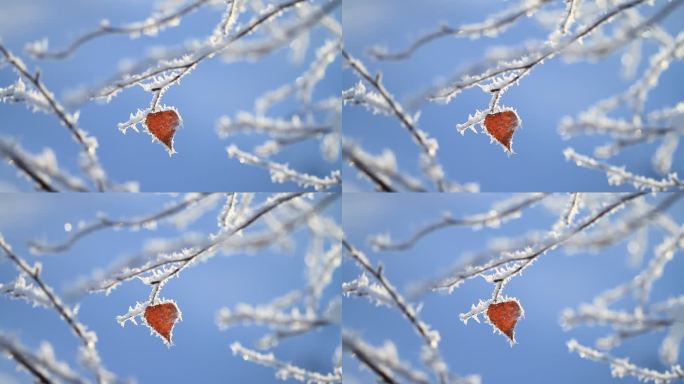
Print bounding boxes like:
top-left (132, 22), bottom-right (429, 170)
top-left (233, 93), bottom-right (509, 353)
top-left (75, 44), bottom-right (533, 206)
top-left (559, 20), bottom-right (684, 186)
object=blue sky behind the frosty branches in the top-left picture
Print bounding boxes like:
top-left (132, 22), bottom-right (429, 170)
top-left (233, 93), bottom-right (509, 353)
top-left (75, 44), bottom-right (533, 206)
top-left (0, 0), bottom-right (341, 191)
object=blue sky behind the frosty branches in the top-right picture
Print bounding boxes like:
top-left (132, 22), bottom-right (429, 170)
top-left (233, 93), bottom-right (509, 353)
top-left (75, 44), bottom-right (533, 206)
top-left (343, 0), bottom-right (684, 192)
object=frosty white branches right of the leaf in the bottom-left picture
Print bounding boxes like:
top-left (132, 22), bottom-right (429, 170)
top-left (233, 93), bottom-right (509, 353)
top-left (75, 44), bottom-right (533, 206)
top-left (216, 201), bottom-right (342, 383)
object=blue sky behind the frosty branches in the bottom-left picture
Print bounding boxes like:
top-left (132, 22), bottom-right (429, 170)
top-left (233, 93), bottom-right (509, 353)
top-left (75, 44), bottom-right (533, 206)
top-left (0, 194), bottom-right (340, 383)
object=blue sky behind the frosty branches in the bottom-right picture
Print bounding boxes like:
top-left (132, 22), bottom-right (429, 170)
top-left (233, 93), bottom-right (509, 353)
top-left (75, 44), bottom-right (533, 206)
top-left (342, 193), bottom-right (684, 384)
